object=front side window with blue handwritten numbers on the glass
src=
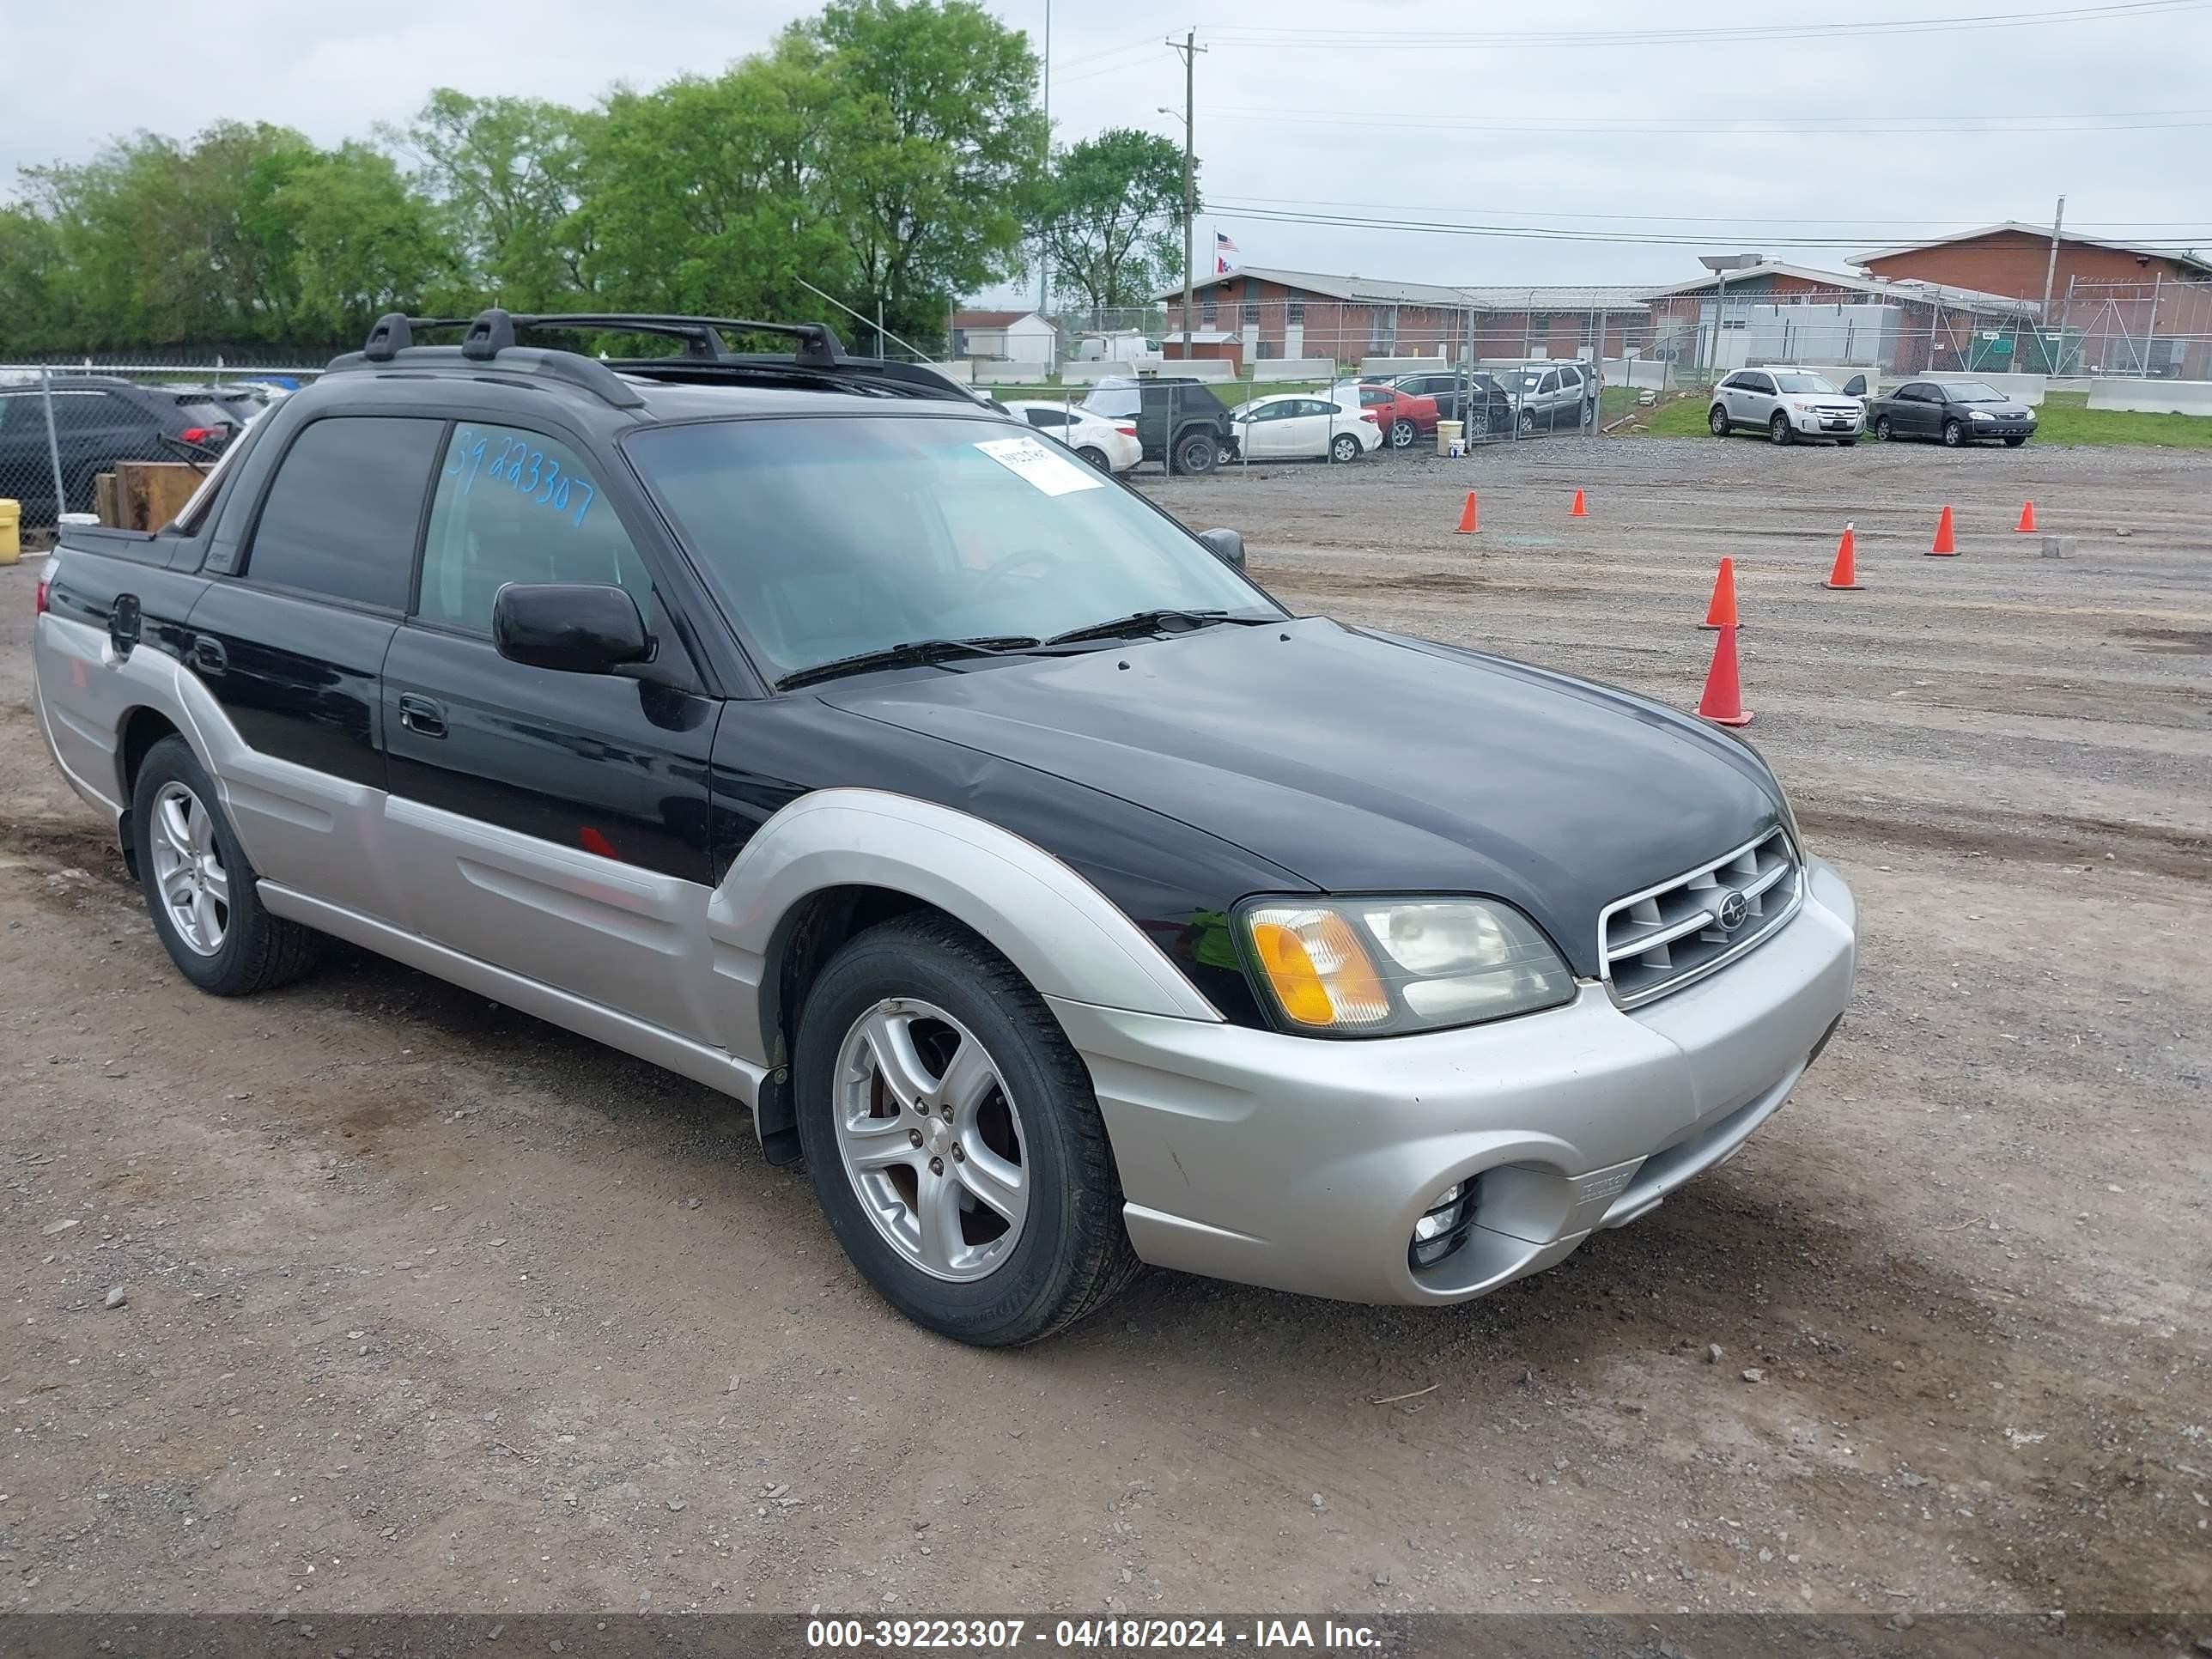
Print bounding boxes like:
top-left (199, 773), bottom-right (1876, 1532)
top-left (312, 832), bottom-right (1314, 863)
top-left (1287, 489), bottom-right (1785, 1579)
top-left (416, 420), bottom-right (653, 635)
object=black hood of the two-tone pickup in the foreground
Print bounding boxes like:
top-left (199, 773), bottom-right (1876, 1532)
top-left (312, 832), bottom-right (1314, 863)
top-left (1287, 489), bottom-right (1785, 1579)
top-left (818, 617), bottom-right (1781, 973)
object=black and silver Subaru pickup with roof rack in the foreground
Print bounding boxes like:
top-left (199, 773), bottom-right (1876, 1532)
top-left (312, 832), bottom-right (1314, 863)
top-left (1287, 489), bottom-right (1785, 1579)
top-left (33, 312), bottom-right (1856, 1343)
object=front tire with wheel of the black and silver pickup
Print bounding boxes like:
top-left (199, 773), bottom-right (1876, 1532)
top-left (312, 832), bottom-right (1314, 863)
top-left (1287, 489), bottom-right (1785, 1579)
top-left (794, 915), bottom-right (1139, 1347)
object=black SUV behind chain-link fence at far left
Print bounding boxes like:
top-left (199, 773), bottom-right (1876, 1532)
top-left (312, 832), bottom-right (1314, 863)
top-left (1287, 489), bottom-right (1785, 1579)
top-left (0, 374), bottom-right (246, 525)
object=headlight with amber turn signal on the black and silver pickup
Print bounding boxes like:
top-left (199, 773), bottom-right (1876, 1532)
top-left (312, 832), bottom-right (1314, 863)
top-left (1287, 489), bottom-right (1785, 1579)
top-left (1239, 898), bottom-right (1575, 1037)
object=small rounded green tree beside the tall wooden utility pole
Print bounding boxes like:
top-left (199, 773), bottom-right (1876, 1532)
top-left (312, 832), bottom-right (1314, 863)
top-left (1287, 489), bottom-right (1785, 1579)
top-left (1040, 126), bottom-right (1197, 305)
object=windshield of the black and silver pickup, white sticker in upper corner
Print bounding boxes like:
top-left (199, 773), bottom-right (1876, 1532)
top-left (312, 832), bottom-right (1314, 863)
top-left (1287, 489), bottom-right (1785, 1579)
top-left (629, 416), bottom-right (1281, 679)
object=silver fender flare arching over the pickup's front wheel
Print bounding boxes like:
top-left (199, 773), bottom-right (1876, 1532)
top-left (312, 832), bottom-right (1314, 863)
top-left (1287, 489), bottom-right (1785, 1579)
top-left (708, 790), bottom-right (1221, 1066)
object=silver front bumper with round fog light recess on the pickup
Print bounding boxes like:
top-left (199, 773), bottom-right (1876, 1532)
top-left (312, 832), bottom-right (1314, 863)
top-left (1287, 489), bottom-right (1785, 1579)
top-left (1051, 858), bottom-right (1858, 1303)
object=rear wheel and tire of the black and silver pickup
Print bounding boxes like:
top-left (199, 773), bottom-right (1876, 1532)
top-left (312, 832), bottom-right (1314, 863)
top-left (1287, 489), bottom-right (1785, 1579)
top-left (131, 737), bottom-right (323, 998)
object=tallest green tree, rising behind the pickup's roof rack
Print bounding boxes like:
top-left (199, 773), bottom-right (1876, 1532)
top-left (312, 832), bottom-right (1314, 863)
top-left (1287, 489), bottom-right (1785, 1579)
top-left (779, 0), bottom-right (1044, 351)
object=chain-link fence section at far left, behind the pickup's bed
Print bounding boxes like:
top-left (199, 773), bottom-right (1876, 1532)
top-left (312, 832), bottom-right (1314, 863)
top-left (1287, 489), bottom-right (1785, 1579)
top-left (0, 358), bottom-right (323, 531)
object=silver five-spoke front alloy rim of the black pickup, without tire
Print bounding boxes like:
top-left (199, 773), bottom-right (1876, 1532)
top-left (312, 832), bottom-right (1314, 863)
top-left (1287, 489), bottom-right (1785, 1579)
top-left (832, 998), bottom-right (1029, 1281)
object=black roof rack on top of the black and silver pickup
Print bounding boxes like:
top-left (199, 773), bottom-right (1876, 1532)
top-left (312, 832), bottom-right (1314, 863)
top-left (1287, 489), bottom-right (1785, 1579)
top-left (330, 305), bottom-right (973, 410)
